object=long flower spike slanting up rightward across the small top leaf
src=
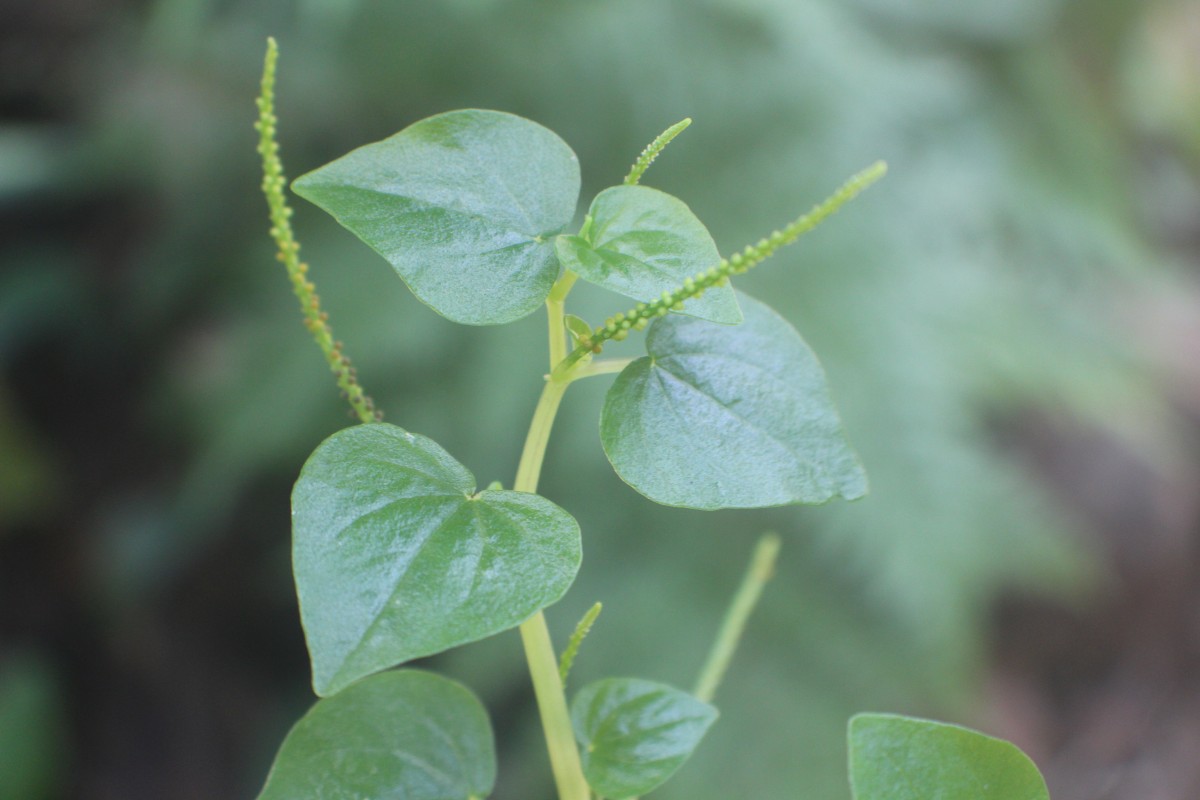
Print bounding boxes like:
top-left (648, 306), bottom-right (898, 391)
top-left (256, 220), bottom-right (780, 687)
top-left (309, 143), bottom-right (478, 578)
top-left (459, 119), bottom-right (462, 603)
top-left (559, 161), bottom-right (888, 379)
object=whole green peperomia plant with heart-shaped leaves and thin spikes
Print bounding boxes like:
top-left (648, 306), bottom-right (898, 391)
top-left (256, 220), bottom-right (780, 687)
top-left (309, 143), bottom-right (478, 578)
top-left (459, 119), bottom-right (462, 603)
top-left (250, 35), bottom-right (1046, 800)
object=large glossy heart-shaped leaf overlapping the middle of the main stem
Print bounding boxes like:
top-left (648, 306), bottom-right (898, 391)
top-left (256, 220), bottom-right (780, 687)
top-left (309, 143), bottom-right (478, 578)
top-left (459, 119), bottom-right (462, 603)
top-left (292, 423), bottom-right (581, 696)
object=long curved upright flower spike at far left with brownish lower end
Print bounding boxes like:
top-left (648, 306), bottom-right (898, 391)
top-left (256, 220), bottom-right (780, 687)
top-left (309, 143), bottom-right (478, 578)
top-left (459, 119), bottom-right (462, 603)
top-left (254, 38), bottom-right (383, 422)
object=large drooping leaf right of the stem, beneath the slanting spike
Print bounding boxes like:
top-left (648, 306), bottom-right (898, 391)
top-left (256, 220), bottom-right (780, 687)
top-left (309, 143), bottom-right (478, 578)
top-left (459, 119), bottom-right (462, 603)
top-left (600, 293), bottom-right (866, 509)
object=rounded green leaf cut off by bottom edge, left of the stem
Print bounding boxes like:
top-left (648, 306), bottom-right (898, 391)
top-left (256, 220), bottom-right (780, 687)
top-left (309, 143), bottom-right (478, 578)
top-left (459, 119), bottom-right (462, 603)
top-left (258, 669), bottom-right (496, 800)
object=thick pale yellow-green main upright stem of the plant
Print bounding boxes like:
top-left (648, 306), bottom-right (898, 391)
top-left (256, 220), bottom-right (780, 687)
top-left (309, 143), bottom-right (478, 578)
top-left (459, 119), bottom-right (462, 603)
top-left (512, 367), bottom-right (592, 800)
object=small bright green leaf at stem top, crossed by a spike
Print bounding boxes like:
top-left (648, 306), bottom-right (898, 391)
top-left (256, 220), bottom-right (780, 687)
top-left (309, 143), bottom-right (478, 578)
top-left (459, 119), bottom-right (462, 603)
top-left (556, 186), bottom-right (742, 324)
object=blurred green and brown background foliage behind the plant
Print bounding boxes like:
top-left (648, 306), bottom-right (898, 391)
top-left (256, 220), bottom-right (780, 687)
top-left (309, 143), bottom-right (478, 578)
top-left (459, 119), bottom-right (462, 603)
top-left (0, 0), bottom-right (1200, 800)
